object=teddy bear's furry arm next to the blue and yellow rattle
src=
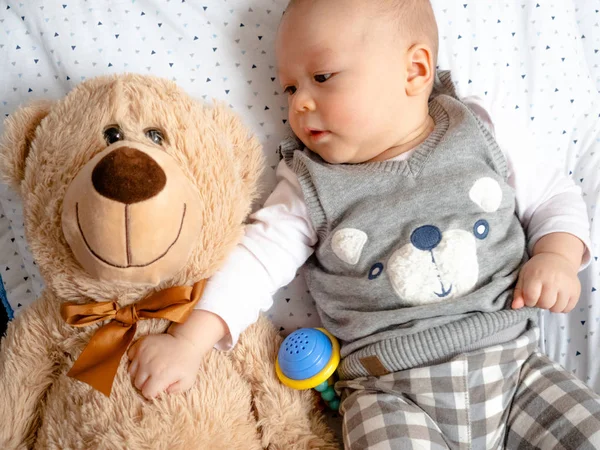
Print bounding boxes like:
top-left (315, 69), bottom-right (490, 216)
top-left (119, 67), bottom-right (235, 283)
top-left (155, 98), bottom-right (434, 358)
top-left (232, 317), bottom-right (339, 450)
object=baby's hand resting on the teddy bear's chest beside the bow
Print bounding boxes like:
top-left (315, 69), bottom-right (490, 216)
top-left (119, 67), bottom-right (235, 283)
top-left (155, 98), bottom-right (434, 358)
top-left (127, 333), bottom-right (205, 399)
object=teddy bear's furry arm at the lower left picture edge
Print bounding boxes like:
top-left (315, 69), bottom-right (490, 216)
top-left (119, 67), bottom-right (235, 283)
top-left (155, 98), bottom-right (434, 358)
top-left (0, 295), bottom-right (59, 450)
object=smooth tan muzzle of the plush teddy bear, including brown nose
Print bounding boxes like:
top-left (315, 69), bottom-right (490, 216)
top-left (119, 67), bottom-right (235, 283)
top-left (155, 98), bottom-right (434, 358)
top-left (62, 142), bottom-right (200, 284)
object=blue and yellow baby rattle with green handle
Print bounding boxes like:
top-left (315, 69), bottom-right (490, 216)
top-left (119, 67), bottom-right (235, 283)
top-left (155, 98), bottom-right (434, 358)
top-left (275, 328), bottom-right (340, 411)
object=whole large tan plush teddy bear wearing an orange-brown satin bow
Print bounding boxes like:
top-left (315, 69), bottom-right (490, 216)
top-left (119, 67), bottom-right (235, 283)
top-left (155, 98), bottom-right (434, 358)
top-left (0, 74), bottom-right (338, 450)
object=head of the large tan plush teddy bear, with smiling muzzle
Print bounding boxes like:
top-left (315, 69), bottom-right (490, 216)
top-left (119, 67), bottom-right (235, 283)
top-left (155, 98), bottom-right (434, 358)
top-left (0, 74), bottom-right (262, 299)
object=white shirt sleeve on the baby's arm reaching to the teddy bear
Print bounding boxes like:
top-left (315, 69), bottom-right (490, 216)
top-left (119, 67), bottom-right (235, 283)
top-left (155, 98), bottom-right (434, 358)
top-left (196, 161), bottom-right (317, 350)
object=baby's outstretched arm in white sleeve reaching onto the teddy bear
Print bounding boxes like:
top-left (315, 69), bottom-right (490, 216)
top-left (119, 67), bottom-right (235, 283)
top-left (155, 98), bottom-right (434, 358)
top-left (128, 162), bottom-right (317, 398)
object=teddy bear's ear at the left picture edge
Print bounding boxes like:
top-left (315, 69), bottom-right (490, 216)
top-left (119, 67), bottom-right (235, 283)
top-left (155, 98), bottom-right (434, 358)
top-left (0, 100), bottom-right (52, 190)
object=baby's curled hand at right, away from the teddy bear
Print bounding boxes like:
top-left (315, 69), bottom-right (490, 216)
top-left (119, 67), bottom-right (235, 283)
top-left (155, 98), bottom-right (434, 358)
top-left (512, 253), bottom-right (581, 313)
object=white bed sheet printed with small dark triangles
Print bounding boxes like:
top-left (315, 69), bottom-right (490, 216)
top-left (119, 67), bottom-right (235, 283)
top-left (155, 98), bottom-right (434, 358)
top-left (0, 0), bottom-right (600, 392)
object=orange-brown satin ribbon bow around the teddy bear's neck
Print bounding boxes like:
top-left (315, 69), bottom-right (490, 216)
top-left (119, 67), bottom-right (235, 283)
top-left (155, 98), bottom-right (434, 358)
top-left (60, 280), bottom-right (206, 397)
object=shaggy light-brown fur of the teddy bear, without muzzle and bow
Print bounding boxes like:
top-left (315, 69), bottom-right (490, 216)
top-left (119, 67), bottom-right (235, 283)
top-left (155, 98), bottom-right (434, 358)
top-left (0, 75), bottom-right (337, 450)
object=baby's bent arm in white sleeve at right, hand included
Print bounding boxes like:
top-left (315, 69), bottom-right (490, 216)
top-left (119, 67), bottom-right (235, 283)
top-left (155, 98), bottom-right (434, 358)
top-left (472, 96), bottom-right (590, 312)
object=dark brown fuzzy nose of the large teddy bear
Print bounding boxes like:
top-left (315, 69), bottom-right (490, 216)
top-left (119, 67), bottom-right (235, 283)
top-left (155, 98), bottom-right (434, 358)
top-left (92, 147), bottom-right (167, 205)
